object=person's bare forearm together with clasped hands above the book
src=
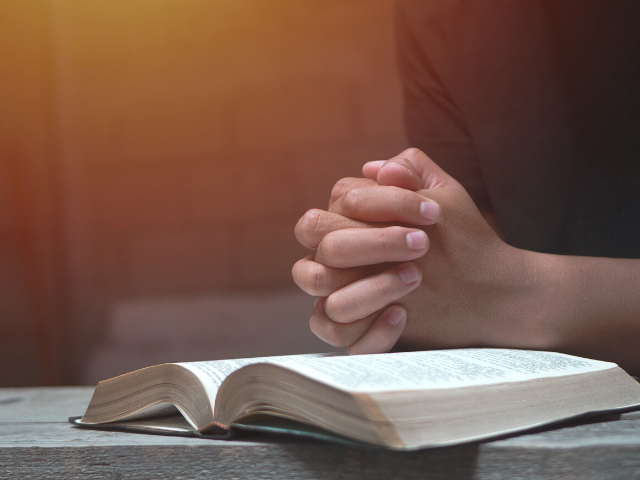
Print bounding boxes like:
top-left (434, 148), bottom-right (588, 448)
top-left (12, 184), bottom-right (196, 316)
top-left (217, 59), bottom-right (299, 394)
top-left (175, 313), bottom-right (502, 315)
top-left (294, 150), bottom-right (640, 375)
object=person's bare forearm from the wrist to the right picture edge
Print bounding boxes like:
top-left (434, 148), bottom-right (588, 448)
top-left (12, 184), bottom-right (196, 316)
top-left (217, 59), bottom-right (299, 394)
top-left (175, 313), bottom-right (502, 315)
top-left (529, 252), bottom-right (640, 375)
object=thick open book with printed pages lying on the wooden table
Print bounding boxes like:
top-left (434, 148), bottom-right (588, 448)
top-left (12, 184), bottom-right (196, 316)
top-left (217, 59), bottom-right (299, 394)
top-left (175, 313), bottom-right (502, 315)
top-left (73, 348), bottom-right (640, 450)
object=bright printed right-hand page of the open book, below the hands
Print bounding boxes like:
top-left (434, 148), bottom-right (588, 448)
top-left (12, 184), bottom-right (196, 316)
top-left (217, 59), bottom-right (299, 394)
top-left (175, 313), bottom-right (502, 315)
top-left (274, 348), bottom-right (616, 392)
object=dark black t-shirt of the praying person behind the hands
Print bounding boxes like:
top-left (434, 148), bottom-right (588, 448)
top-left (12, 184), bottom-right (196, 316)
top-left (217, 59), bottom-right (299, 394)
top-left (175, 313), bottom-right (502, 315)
top-left (397, 0), bottom-right (640, 258)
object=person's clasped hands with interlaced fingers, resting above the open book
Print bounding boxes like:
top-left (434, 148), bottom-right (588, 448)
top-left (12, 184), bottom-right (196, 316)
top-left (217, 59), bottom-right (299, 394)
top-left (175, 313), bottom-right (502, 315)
top-left (293, 149), bottom-right (549, 354)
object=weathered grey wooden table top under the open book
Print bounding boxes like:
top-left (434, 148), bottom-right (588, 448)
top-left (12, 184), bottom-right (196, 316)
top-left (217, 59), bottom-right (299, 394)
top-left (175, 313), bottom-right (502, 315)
top-left (0, 387), bottom-right (640, 480)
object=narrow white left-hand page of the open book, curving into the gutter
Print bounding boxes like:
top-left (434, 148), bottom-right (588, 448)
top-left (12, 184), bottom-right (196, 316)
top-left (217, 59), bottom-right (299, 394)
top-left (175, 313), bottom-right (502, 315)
top-left (176, 353), bottom-right (342, 398)
